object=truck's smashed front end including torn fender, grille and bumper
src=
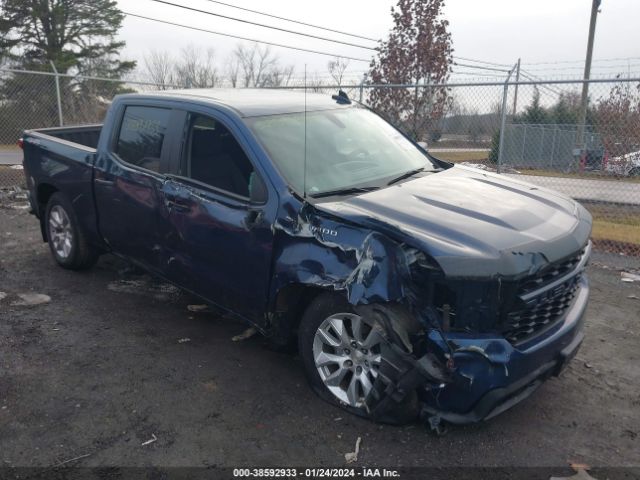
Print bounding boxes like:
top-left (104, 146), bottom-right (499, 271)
top-left (266, 194), bottom-right (590, 432)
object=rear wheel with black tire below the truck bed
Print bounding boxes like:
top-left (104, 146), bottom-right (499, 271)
top-left (43, 192), bottom-right (99, 270)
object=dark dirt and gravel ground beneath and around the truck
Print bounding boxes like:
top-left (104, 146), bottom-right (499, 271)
top-left (0, 198), bottom-right (640, 472)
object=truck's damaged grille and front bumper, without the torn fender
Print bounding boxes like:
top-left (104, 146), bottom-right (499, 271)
top-left (358, 245), bottom-right (590, 432)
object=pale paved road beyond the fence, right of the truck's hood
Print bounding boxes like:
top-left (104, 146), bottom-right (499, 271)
top-left (506, 174), bottom-right (640, 205)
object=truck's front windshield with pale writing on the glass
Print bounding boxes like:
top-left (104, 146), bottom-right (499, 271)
top-left (247, 107), bottom-right (434, 196)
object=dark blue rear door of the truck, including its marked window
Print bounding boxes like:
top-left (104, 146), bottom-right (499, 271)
top-left (94, 102), bottom-right (184, 271)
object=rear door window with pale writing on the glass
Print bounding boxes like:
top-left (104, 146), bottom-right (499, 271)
top-left (115, 106), bottom-right (171, 172)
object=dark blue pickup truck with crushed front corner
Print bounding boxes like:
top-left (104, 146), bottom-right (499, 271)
top-left (23, 90), bottom-right (591, 430)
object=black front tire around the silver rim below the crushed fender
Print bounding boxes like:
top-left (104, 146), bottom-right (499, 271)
top-left (298, 292), bottom-right (419, 424)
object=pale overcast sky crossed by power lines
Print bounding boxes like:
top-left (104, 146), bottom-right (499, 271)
top-left (118, 0), bottom-right (640, 78)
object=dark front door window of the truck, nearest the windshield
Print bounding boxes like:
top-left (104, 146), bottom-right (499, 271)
top-left (187, 115), bottom-right (253, 197)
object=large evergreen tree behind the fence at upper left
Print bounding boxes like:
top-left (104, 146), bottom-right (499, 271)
top-left (0, 0), bottom-right (135, 139)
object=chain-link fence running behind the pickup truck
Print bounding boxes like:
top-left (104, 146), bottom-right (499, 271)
top-left (0, 70), bottom-right (640, 256)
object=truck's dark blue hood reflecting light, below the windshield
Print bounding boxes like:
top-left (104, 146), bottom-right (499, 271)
top-left (316, 166), bottom-right (591, 277)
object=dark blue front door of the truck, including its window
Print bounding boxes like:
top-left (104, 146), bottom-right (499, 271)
top-left (163, 112), bottom-right (275, 319)
